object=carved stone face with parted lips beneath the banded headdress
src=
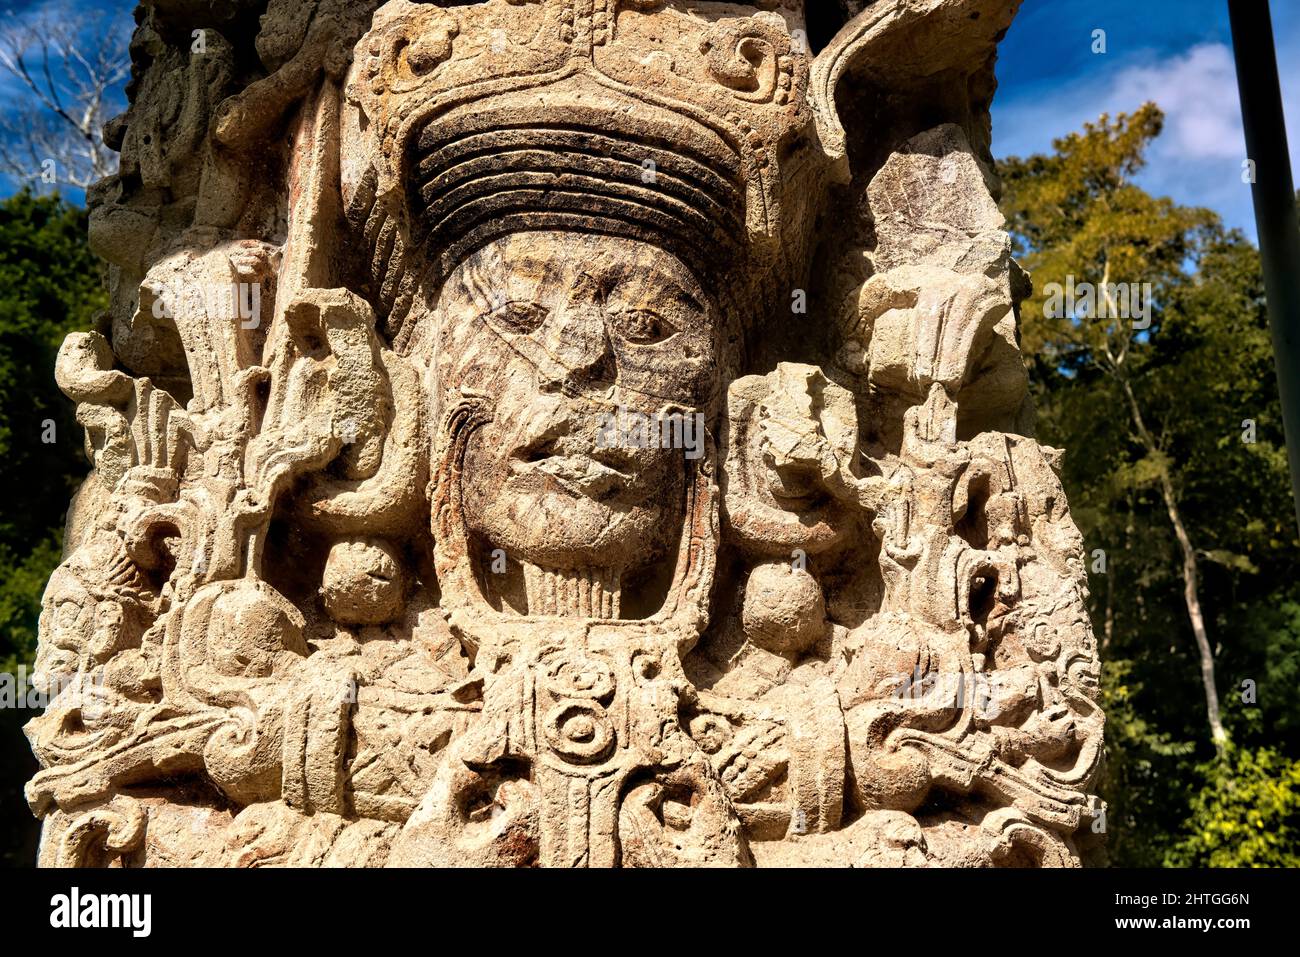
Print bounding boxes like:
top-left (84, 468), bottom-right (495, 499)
top-left (425, 233), bottom-right (716, 570)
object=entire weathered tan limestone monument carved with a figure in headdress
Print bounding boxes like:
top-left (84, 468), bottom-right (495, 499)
top-left (27, 0), bottom-right (1102, 866)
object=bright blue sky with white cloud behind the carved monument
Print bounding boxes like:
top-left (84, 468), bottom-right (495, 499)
top-left (0, 0), bottom-right (1300, 238)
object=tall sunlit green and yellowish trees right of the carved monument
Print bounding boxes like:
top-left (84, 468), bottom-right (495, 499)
top-left (1000, 104), bottom-right (1300, 866)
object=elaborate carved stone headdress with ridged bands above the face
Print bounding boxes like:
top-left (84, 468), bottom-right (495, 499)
top-left (343, 0), bottom-right (828, 341)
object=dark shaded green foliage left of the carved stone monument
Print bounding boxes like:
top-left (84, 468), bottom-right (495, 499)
top-left (0, 192), bottom-right (107, 668)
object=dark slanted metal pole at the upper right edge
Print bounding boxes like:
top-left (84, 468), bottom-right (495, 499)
top-left (1227, 0), bottom-right (1300, 524)
